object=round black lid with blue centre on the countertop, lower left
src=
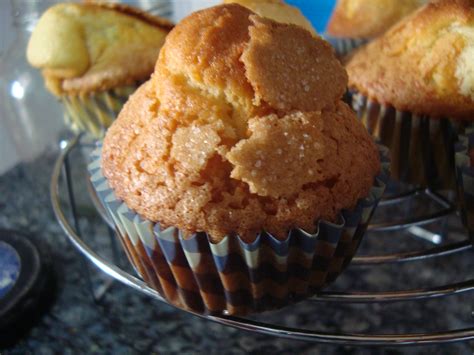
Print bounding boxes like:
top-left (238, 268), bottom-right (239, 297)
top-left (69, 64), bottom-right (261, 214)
top-left (0, 230), bottom-right (55, 346)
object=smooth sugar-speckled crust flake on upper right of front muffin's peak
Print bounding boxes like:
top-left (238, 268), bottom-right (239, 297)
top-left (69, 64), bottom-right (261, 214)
top-left (242, 16), bottom-right (347, 112)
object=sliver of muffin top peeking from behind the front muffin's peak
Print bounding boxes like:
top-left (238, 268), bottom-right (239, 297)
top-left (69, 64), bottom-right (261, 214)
top-left (224, 0), bottom-right (316, 35)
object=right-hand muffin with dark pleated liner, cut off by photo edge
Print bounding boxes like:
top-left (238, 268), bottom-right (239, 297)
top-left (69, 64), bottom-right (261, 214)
top-left (346, 0), bottom-right (474, 189)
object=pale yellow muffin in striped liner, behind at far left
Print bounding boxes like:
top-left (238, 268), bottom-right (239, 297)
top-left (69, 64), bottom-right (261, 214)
top-left (27, 3), bottom-right (173, 137)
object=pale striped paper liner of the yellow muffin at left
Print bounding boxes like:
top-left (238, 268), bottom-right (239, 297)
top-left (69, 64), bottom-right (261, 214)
top-left (61, 83), bottom-right (140, 138)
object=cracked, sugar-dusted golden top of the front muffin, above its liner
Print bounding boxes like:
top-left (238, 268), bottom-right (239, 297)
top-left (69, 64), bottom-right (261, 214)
top-left (102, 4), bottom-right (380, 242)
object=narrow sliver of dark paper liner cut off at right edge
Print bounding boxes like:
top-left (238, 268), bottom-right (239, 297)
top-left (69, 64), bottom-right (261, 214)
top-left (456, 126), bottom-right (474, 245)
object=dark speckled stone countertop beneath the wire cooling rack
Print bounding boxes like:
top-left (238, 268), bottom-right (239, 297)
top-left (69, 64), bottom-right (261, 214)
top-left (0, 146), bottom-right (474, 355)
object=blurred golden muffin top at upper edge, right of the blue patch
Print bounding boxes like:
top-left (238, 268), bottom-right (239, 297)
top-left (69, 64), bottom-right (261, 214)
top-left (327, 0), bottom-right (428, 39)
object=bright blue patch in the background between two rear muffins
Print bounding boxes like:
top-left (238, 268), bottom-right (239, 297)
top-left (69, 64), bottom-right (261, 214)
top-left (286, 0), bottom-right (336, 33)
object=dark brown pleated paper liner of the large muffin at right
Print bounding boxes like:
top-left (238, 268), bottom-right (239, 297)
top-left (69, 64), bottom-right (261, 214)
top-left (348, 92), bottom-right (465, 190)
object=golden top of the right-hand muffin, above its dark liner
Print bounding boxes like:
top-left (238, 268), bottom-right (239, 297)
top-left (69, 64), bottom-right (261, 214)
top-left (346, 0), bottom-right (474, 120)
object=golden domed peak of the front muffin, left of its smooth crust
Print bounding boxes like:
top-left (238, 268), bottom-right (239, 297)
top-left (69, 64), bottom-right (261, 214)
top-left (154, 5), bottom-right (258, 124)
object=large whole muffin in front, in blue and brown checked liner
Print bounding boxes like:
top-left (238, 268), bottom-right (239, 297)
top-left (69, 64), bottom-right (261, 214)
top-left (89, 4), bottom-right (387, 314)
